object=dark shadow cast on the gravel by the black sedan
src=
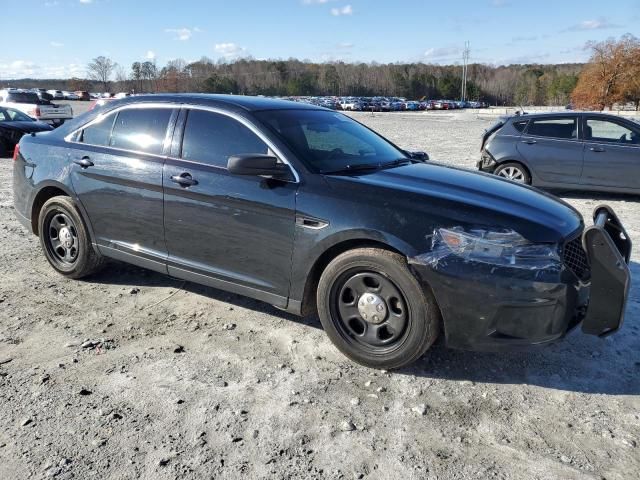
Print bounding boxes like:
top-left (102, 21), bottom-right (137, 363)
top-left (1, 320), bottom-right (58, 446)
top-left (88, 261), bottom-right (640, 395)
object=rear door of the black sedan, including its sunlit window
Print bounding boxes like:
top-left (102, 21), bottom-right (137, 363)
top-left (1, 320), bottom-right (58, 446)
top-left (69, 104), bottom-right (178, 271)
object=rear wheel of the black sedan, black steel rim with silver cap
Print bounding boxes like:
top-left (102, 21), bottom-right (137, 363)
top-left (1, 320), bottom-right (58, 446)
top-left (38, 196), bottom-right (105, 279)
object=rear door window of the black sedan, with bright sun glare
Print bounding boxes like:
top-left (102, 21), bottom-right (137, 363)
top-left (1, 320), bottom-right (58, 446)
top-left (109, 108), bottom-right (172, 154)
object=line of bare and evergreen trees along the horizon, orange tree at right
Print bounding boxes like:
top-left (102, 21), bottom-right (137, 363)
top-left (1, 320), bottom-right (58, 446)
top-left (6, 34), bottom-right (640, 110)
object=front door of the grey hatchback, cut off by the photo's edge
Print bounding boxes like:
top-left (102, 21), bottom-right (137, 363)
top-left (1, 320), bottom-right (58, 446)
top-left (582, 116), bottom-right (640, 191)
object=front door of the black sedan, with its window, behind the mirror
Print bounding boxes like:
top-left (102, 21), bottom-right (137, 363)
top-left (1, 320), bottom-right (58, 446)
top-left (163, 107), bottom-right (297, 306)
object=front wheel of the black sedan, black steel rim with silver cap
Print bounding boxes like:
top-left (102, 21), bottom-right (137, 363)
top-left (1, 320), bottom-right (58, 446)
top-left (317, 248), bottom-right (441, 369)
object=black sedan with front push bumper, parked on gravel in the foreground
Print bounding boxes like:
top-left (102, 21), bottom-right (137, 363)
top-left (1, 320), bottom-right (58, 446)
top-left (13, 95), bottom-right (631, 368)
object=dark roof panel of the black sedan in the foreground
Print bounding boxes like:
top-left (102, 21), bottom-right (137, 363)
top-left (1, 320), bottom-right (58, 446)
top-left (110, 93), bottom-right (327, 112)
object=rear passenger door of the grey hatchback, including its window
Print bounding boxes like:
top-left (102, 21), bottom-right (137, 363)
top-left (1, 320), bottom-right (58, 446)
top-left (517, 115), bottom-right (584, 184)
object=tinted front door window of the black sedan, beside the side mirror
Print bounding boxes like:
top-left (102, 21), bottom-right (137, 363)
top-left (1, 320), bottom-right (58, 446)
top-left (182, 110), bottom-right (269, 168)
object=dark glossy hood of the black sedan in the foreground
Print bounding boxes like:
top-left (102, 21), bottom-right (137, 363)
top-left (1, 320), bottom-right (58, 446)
top-left (327, 163), bottom-right (583, 242)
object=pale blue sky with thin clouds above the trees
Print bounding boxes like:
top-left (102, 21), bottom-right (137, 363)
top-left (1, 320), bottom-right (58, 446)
top-left (0, 0), bottom-right (640, 80)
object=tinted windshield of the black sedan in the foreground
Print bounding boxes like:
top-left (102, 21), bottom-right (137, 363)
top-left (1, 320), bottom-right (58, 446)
top-left (256, 110), bottom-right (408, 173)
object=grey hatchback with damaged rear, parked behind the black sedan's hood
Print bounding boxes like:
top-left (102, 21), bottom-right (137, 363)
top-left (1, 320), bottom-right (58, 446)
top-left (477, 112), bottom-right (640, 194)
